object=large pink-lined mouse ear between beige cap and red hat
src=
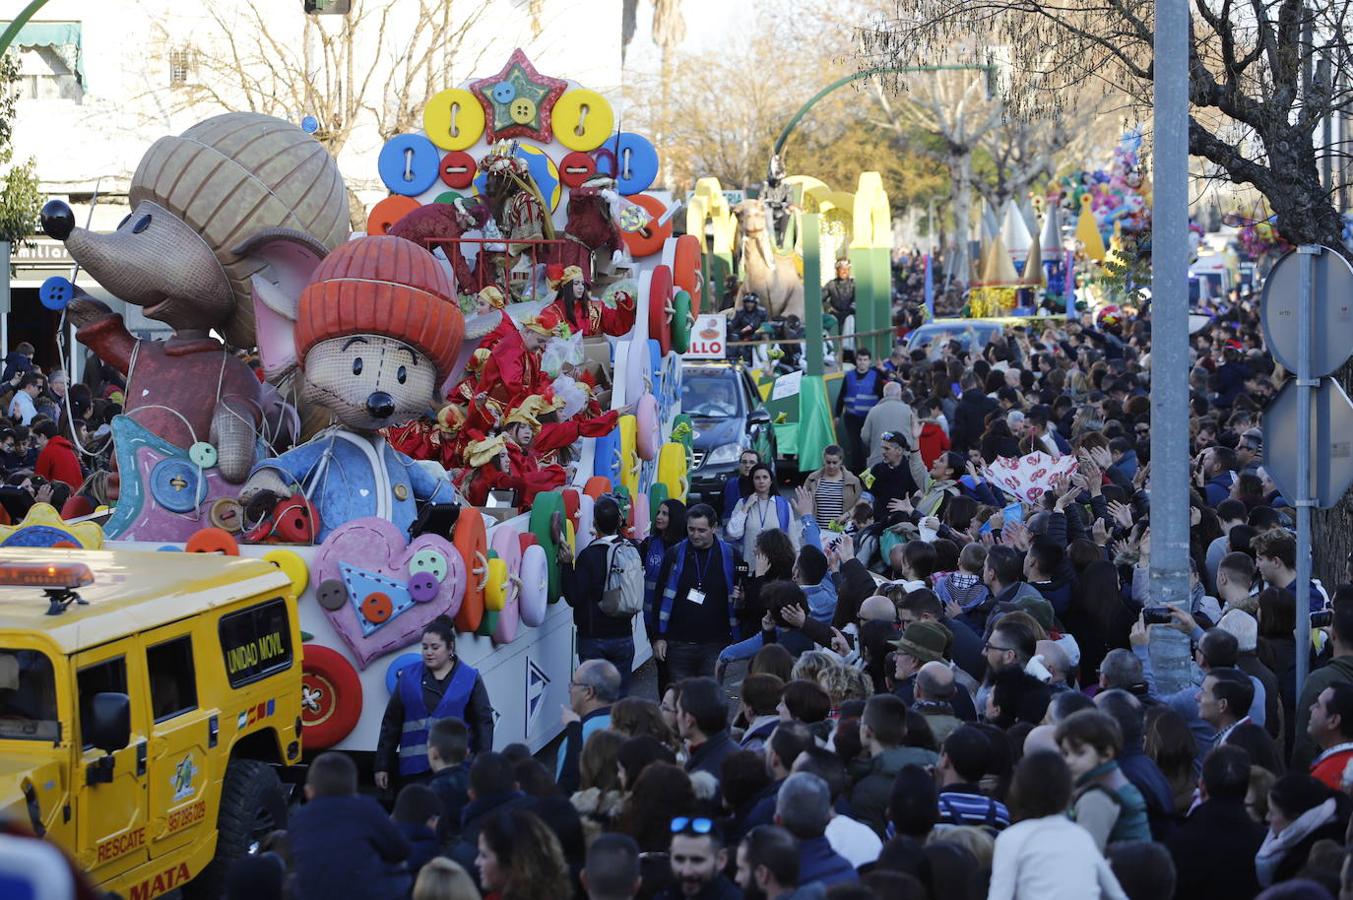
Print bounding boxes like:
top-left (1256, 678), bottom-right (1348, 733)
top-left (235, 229), bottom-right (329, 380)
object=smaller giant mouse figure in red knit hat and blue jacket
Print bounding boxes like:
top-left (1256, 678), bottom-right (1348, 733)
top-left (241, 235), bottom-right (465, 541)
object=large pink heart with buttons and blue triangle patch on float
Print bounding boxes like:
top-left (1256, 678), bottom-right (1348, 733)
top-left (313, 516), bottom-right (465, 669)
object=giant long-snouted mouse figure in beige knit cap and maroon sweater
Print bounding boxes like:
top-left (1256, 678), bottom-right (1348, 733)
top-left (42, 112), bottom-right (348, 483)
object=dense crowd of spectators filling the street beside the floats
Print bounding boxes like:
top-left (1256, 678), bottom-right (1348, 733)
top-left (110, 267), bottom-right (1353, 900)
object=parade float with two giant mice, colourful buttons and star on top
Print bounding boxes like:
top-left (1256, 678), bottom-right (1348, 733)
top-left (25, 50), bottom-right (692, 752)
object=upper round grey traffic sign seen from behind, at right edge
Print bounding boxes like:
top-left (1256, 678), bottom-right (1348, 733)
top-left (1260, 248), bottom-right (1353, 378)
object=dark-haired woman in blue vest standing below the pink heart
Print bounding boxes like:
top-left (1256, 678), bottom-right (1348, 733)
top-left (376, 616), bottom-right (494, 790)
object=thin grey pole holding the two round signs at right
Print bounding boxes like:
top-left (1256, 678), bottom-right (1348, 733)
top-left (1293, 244), bottom-right (1323, 697)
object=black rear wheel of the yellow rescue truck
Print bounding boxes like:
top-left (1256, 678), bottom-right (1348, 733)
top-left (183, 759), bottom-right (287, 900)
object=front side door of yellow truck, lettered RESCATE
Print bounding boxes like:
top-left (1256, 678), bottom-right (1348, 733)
top-left (70, 639), bottom-right (149, 882)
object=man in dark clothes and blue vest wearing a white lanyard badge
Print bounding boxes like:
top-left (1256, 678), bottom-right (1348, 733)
top-left (651, 503), bottom-right (737, 694)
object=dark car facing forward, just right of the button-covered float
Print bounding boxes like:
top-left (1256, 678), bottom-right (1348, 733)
top-left (681, 361), bottom-right (775, 514)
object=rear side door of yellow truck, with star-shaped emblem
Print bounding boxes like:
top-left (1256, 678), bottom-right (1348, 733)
top-left (145, 621), bottom-right (211, 858)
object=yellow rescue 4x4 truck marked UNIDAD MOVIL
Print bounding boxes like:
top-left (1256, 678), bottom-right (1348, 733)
top-left (0, 548), bottom-right (300, 900)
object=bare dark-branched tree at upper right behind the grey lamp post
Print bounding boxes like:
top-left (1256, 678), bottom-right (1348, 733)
top-left (858, 0), bottom-right (1353, 581)
